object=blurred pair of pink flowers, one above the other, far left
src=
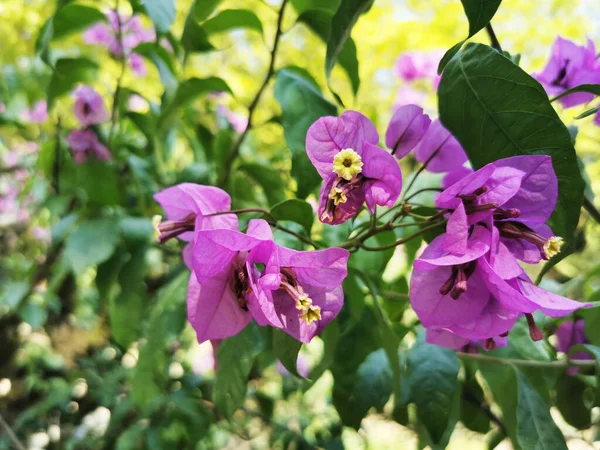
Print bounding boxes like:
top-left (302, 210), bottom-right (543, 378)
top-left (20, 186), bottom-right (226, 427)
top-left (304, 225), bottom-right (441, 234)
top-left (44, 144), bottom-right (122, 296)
top-left (67, 86), bottom-right (111, 164)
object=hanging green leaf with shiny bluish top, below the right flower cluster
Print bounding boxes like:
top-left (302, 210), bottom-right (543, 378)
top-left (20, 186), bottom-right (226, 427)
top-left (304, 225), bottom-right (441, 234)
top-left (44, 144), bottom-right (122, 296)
top-left (407, 343), bottom-right (460, 445)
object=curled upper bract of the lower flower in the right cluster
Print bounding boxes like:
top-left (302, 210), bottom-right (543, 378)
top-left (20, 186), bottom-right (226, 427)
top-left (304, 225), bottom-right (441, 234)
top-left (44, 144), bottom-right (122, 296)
top-left (415, 227), bottom-right (490, 268)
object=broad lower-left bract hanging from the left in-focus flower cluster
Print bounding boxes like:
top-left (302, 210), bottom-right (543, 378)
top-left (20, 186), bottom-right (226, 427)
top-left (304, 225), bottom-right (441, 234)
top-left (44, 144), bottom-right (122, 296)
top-left (187, 271), bottom-right (251, 343)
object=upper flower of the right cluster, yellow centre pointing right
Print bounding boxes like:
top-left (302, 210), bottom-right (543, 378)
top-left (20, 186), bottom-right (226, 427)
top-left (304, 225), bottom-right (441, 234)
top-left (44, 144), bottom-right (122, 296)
top-left (436, 155), bottom-right (562, 264)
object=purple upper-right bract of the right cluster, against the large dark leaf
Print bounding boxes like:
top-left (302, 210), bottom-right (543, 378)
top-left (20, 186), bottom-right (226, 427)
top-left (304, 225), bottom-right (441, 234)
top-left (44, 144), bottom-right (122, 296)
top-left (494, 155), bottom-right (558, 223)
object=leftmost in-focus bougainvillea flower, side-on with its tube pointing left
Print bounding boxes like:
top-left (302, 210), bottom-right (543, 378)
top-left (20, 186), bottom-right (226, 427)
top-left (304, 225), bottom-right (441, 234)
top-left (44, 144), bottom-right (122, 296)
top-left (154, 183), bottom-right (238, 243)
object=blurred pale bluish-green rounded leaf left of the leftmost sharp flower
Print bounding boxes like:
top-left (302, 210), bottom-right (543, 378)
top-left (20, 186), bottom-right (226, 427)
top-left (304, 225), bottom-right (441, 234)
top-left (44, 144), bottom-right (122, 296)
top-left (65, 217), bottom-right (119, 275)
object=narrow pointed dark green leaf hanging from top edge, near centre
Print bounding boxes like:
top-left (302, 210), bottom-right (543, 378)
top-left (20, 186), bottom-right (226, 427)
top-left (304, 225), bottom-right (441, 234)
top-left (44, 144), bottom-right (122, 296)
top-left (325, 0), bottom-right (374, 93)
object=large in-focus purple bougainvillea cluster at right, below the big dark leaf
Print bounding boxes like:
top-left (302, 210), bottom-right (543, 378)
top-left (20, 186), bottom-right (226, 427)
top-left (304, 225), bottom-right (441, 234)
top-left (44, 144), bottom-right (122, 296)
top-left (410, 155), bottom-right (585, 349)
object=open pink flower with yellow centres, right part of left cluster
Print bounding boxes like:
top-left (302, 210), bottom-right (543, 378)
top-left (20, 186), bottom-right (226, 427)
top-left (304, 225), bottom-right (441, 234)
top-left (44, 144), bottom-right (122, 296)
top-left (248, 242), bottom-right (349, 342)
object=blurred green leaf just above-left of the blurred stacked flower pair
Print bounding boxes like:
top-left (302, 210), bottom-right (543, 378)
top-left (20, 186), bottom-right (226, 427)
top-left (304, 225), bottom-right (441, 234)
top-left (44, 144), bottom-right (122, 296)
top-left (48, 58), bottom-right (98, 110)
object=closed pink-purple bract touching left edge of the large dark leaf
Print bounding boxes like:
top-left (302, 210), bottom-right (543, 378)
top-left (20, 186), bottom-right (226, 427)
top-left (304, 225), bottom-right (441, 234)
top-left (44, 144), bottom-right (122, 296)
top-left (415, 119), bottom-right (467, 173)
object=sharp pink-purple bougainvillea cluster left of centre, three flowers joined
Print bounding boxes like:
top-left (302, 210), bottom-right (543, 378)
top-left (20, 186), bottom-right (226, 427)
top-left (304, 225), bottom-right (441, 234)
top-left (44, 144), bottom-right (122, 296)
top-left (155, 183), bottom-right (349, 342)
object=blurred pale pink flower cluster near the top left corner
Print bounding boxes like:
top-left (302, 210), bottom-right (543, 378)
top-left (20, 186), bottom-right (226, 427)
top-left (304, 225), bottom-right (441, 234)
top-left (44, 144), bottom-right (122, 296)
top-left (83, 11), bottom-right (156, 76)
